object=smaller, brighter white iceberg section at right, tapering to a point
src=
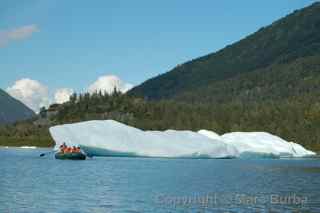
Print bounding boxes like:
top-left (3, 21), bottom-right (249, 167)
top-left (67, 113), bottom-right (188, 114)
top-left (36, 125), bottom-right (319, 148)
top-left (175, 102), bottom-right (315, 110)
top-left (198, 130), bottom-right (316, 158)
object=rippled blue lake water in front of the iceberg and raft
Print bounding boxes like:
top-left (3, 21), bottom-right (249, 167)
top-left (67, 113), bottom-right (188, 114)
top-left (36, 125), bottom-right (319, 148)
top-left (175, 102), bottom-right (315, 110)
top-left (0, 148), bottom-right (320, 213)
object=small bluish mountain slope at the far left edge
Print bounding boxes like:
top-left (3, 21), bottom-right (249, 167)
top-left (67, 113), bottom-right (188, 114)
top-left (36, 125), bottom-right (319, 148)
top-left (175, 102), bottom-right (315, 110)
top-left (0, 89), bottom-right (35, 124)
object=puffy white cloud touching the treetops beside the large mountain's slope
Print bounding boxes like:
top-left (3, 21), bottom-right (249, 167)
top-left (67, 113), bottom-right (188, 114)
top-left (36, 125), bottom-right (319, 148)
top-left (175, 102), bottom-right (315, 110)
top-left (88, 75), bottom-right (133, 94)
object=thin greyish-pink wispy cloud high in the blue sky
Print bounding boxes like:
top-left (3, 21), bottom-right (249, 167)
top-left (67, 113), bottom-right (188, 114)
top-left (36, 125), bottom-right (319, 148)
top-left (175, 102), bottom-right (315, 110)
top-left (0, 24), bottom-right (40, 47)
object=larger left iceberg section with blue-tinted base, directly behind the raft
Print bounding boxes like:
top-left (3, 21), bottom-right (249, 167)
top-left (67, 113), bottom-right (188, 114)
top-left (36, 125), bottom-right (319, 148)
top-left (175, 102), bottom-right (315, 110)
top-left (50, 120), bottom-right (238, 158)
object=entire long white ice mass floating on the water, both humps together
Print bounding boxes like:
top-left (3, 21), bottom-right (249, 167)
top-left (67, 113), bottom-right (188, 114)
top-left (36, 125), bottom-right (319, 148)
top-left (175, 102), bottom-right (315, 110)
top-left (50, 120), bottom-right (315, 158)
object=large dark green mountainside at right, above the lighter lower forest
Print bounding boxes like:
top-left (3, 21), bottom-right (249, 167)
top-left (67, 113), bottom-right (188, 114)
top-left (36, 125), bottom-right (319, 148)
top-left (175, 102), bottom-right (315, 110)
top-left (128, 2), bottom-right (320, 103)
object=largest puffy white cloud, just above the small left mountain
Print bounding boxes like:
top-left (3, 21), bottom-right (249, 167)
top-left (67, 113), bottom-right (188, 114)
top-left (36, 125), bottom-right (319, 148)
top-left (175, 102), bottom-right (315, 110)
top-left (7, 78), bottom-right (49, 112)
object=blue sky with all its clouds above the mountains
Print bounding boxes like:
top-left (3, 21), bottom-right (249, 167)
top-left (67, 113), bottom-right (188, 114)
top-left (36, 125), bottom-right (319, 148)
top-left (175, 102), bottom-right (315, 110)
top-left (0, 0), bottom-right (315, 111)
